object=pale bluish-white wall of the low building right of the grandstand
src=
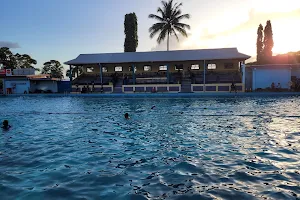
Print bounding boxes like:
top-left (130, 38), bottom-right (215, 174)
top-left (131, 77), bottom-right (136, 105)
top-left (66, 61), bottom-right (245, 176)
top-left (252, 68), bottom-right (292, 90)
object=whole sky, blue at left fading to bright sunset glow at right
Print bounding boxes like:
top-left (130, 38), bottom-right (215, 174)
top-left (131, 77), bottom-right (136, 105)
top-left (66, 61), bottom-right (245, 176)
top-left (0, 0), bottom-right (300, 74)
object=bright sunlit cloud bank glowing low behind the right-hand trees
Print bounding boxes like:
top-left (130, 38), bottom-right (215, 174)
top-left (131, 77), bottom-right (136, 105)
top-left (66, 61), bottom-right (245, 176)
top-left (152, 8), bottom-right (300, 56)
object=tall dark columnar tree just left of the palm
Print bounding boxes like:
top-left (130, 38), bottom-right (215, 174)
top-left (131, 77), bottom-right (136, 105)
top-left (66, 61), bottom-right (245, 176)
top-left (124, 13), bottom-right (138, 52)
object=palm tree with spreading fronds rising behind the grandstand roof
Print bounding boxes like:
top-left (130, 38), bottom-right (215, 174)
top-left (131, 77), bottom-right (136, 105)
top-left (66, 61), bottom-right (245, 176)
top-left (149, 0), bottom-right (191, 51)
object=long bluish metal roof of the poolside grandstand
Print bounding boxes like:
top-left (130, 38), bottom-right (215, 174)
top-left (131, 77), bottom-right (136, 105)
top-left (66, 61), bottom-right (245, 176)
top-left (65, 48), bottom-right (250, 65)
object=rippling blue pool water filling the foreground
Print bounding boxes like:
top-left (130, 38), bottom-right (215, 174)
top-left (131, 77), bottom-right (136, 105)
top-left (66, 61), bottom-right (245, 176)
top-left (0, 97), bottom-right (300, 200)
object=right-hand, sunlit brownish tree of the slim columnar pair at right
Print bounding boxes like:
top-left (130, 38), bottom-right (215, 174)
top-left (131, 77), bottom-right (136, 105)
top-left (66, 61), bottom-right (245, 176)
top-left (263, 20), bottom-right (274, 62)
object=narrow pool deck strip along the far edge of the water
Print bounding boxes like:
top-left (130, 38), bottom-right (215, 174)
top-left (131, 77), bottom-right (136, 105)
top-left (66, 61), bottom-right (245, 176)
top-left (0, 92), bottom-right (300, 98)
